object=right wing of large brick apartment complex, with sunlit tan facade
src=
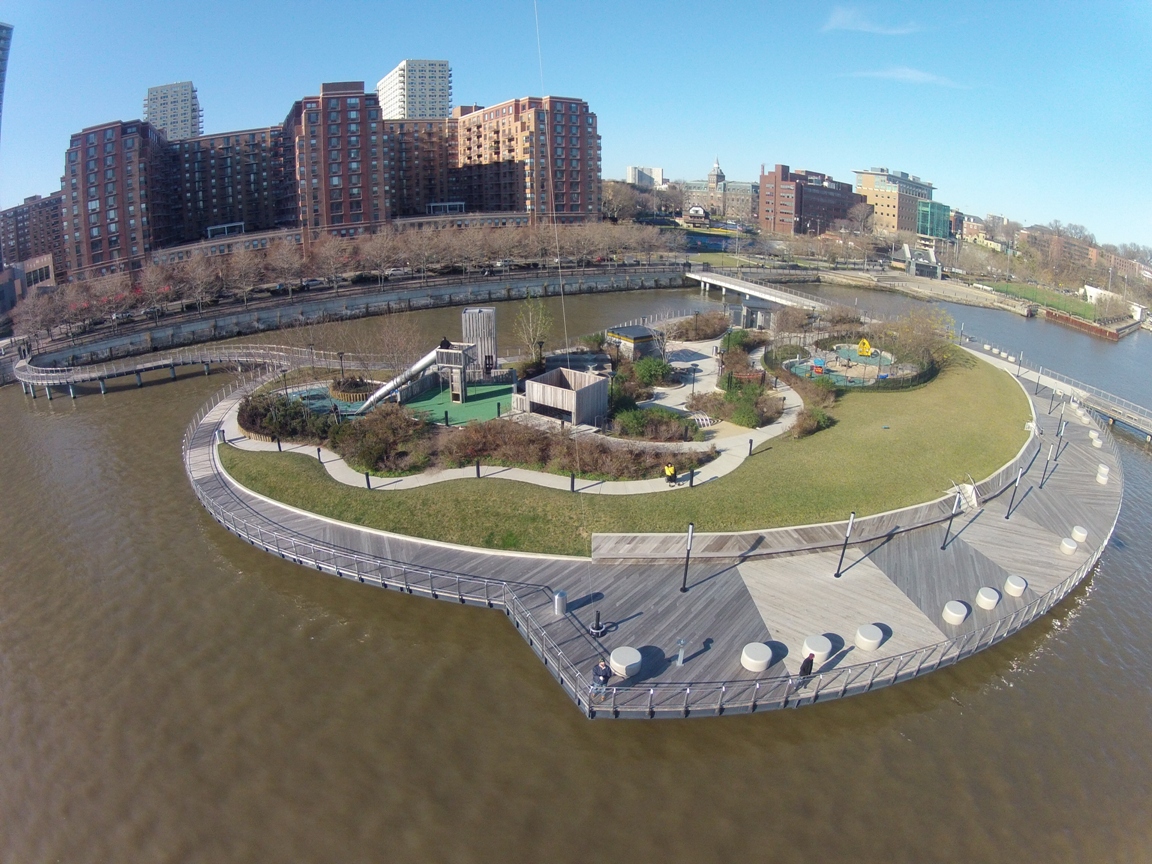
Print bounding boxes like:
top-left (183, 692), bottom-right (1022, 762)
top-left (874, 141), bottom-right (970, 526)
top-left (453, 96), bottom-right (601, 222)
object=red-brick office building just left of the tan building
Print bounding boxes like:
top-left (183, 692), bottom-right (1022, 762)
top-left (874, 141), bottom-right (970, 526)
top-left (760, 165), bottom-right (864, 234)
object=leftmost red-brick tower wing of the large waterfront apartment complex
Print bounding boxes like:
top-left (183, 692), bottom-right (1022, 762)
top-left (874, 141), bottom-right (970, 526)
top-left (61, 120), bottom-right (181, 279)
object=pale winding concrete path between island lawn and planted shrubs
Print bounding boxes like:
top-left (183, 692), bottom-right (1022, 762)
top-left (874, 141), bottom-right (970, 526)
top-left (223, 340), bottom-right (803, 495)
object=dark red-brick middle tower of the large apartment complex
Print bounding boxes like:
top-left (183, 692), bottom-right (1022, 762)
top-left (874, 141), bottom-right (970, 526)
top-left (283, 81), bottom-right (392, 235)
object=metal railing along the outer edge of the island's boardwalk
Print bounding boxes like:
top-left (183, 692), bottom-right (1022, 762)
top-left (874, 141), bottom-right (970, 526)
top-left (181, 371), bottom-right (1123, 718)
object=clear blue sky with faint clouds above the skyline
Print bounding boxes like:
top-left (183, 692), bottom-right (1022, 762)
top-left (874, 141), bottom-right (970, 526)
top-left (0, 0), bottom-right (1152, 244)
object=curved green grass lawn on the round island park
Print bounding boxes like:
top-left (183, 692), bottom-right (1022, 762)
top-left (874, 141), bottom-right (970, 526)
top-left (220, 357), bottom-right (1031, 555)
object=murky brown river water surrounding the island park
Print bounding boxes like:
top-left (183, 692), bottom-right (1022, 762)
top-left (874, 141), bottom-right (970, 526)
top-left (0, 288), bottom-right (1152, 862)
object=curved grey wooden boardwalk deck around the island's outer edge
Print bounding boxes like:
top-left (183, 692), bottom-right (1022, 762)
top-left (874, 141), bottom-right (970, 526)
top-left (184, 350), bottom-right (1123, 718)
